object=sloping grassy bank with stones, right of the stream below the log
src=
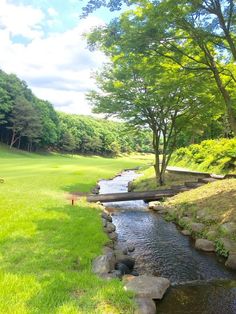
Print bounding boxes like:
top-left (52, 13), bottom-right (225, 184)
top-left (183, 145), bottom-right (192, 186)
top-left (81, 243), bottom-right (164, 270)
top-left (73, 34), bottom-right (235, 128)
top-left (165, 179), bottom-right (236, 256)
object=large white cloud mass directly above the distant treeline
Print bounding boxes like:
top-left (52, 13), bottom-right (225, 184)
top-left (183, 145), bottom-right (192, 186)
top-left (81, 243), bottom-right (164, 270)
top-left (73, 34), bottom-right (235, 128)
top-left (0, 0), bottom-right (105, 114)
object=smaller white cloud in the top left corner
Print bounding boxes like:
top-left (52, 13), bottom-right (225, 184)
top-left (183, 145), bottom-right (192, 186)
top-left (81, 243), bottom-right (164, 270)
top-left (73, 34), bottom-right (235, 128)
top-left (0, 0), bottom-right (44, 39)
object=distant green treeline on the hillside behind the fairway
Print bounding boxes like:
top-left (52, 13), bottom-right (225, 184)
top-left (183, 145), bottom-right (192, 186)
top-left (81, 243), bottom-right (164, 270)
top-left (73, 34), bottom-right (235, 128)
top-left (0, 70), bottom-right (152, 155)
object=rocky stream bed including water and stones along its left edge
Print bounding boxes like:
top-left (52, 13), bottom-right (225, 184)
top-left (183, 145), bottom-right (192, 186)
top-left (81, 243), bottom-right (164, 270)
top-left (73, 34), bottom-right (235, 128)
top-left (93, 171), bottom-right (236, 314)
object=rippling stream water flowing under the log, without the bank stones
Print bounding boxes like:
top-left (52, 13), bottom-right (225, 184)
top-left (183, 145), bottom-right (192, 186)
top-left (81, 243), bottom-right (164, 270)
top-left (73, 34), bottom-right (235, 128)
top-left (99, 170), bottom-right (236, 314)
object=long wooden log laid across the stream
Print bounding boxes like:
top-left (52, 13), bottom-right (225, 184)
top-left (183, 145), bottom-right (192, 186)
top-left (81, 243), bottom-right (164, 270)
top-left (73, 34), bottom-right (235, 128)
top-left (87, 189), bottom-right (177, 203)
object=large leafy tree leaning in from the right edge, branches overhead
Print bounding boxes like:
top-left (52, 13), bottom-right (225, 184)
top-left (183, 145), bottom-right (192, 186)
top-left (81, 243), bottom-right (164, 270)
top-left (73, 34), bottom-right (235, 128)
top-left (85, 0), bottom-right (236, 135)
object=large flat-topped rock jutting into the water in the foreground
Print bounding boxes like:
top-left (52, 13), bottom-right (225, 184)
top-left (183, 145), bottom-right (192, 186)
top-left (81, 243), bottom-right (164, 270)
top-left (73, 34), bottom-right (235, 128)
top-left (125, 275), bottom-right (170, 299)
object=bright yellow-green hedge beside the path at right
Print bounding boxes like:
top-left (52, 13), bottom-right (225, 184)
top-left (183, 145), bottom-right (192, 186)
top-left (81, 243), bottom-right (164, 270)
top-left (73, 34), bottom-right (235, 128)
top-left (171, 138), bottom-right (236, 173)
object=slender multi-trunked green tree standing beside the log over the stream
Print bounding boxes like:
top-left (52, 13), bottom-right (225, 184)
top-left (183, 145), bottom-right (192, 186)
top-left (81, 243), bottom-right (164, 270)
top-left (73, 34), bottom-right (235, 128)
top-left (88, 32), bottom-right (210, 185)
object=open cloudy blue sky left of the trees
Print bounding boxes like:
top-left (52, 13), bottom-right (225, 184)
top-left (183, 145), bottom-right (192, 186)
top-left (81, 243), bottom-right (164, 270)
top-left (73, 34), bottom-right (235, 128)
top-left (0, 0), bottom-right (121, 114)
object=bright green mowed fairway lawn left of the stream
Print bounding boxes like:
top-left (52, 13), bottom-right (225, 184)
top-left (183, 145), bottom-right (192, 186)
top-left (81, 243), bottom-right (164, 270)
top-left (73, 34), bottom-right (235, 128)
top-left (0, 146), bottom-right (150, 314)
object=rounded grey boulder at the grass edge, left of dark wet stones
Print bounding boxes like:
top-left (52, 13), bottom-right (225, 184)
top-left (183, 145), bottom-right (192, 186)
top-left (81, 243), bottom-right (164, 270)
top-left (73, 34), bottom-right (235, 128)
top-left (92, 252), bottom-right (115, 275)
